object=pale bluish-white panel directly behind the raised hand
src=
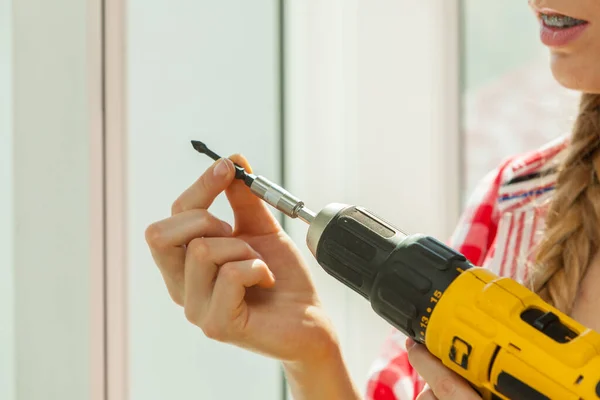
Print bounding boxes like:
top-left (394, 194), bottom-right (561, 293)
top-left (126, 0), bottom-right (282, 400)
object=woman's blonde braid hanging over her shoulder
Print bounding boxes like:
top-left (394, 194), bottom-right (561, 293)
top-left (531, 94), bottom-right (600, 314)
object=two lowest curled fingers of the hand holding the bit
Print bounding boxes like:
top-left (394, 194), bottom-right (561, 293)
top-left (184, 238), bottom-right (270, 339)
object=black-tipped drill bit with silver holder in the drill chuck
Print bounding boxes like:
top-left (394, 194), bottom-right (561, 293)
top-left (192, 140), bottom-right (316, 225)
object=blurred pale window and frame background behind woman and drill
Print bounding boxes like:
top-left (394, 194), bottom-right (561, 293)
top-left (0, 0), bottom-right (577, 400)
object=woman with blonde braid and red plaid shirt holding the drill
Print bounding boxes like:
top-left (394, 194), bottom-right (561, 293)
top-left (146, 0), bottom-right (600, 400)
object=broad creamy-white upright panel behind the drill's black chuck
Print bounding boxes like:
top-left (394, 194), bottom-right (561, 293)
top-left (286, 0), bottom-right (460, 389)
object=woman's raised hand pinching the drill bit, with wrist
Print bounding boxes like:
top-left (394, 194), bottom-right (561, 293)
top-left (146, 156), bottom-right (357, 399)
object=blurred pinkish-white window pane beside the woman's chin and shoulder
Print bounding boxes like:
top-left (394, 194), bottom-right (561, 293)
top-left (463, 0), bottom-right (578, 196)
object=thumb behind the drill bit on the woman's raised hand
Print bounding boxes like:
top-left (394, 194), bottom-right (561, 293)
top-left (225, 154), bottom-right (281, 235)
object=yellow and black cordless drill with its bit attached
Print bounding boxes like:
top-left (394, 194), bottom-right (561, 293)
top-left (192, 141), bottom-right (600, 400)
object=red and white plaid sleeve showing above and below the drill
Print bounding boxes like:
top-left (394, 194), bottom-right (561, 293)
top-left (365, 160), bottom-right (510, 400)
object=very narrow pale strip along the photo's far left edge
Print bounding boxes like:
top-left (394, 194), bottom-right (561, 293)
top-left (0, 0), bottom-right (15, 400)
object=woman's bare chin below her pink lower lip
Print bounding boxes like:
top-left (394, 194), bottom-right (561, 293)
top-left (550, 53), bottom-right (600, 94)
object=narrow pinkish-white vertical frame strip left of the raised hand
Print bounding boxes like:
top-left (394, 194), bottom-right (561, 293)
top-left (103, 0), bottom-right (129, 400)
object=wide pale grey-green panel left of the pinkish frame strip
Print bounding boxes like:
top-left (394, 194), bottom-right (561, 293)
top-left (13, 0), bottom-right (100, 400)
